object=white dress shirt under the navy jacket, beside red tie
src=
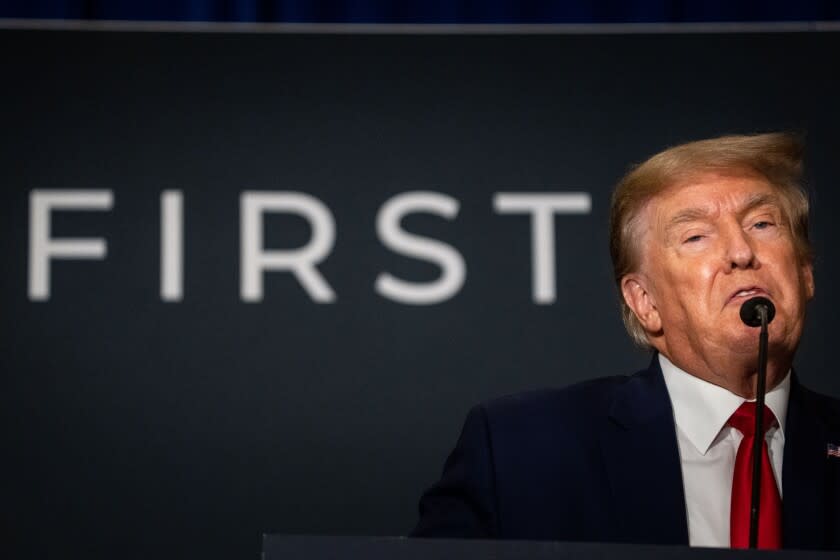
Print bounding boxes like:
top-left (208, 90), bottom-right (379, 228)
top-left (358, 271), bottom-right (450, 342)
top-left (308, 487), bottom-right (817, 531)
top-left (659, 354), bottom-right (790, 547)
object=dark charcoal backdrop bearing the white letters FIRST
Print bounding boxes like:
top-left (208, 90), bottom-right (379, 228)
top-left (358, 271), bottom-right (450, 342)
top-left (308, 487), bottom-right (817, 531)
top-left (0, 30), bottom-right (840, 558)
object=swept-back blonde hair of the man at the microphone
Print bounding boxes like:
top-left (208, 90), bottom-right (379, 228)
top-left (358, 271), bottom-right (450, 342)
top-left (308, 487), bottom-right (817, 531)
top-left (610, 132), bottom-right (813, 348)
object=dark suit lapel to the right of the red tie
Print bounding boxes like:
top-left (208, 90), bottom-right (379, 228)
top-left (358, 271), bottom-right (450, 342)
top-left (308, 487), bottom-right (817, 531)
top-left (782, 374), bottom-right (828, 548)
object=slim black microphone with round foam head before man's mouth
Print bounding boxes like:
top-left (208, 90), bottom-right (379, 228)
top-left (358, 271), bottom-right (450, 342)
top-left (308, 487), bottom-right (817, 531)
top-left (741, 297), bottom-right (776, 548)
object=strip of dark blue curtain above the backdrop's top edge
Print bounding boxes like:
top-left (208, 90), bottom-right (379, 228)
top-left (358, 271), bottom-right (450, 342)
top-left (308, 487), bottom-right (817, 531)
top-left (0, 0), bottom-right (840, 23)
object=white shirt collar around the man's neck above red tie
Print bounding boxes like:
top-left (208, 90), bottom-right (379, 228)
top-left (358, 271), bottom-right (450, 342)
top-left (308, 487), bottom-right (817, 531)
top-left (659, 354), bottom-right (790, 455)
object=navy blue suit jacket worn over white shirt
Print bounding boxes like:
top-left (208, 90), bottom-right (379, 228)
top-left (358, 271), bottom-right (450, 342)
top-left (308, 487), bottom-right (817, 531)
top-left (412, 357), bottom-right (840, 549)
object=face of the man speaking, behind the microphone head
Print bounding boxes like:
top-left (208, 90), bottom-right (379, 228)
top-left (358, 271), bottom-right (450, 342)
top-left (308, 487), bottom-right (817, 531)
top-left (623, 173), bottom-right (814, 380)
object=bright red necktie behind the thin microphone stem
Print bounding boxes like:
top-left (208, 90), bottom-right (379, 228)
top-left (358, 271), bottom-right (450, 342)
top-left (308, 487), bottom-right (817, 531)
top-left (729, 402), bottom-right (782, 548)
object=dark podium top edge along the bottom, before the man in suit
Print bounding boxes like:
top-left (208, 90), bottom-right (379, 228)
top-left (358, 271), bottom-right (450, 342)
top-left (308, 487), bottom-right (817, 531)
top-left (262, 535), bottom-right (837, 560)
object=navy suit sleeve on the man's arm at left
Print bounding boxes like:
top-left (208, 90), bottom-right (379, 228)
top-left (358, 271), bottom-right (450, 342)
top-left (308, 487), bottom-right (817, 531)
top-left (411, 406), bottom-right (499, 538)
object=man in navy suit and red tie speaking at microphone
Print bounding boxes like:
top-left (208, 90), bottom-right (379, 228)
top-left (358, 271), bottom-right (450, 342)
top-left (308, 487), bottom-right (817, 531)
top-left (413, 134), bottom-right (840, 549)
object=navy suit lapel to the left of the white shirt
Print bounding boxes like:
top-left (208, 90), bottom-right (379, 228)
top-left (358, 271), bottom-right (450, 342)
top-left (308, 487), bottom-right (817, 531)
top-left (601, 355), bottom-right (688, 544)
